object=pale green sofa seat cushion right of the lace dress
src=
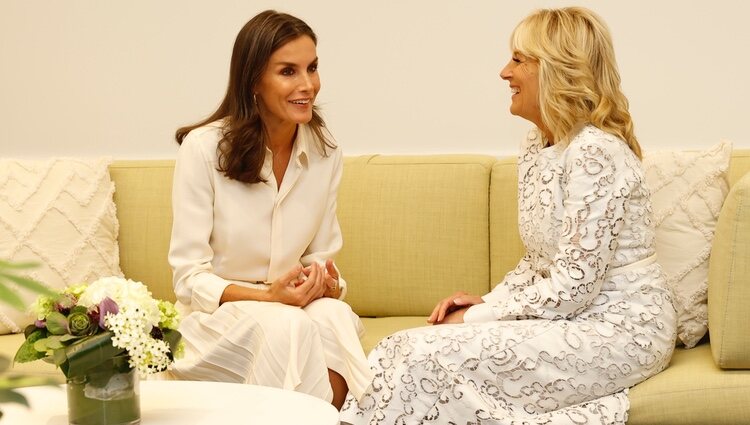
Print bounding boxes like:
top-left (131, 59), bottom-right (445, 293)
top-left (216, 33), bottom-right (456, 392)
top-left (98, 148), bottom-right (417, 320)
top-left (628, 344), bottom-right (750, 425)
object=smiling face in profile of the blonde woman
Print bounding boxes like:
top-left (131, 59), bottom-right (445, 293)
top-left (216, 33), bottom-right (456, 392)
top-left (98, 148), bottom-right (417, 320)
top-left (500, 52), bottom-right (543, 129)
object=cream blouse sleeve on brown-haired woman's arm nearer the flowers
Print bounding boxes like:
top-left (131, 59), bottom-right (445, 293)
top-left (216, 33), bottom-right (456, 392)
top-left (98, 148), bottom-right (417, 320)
top-left (169, 133), bottom-right (229, 313)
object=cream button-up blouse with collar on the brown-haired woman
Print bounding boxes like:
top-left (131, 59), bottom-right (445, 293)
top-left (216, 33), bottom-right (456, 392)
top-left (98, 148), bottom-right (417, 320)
top-left (169, 121), bottom-right (346, 313)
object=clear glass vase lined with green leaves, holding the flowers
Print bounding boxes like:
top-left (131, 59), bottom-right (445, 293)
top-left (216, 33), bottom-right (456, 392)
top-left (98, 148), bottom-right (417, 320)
top-left (67, 356), bottom-right (141, 425)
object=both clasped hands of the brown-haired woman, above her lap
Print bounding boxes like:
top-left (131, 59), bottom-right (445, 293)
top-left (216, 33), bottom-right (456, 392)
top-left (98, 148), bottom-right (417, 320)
top-left (268, 260), bottom-right (341, 307)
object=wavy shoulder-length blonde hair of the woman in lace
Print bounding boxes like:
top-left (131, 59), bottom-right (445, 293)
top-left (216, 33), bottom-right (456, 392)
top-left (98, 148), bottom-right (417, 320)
top-left (510, 7), bottom-right (641, 158)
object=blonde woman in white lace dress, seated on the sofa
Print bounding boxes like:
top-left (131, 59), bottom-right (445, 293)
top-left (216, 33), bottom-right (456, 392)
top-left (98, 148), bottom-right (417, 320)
top-left (342, 8), bottom-right (676, 424)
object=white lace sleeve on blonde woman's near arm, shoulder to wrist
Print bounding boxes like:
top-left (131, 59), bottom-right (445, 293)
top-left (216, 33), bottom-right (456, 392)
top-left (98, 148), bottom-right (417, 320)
top-left (469, 140), bottom-right (628, 320)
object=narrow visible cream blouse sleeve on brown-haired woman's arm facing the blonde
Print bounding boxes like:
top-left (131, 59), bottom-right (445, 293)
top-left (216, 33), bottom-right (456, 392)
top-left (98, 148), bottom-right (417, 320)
top-left (300, 149), bottom-right (346, 300)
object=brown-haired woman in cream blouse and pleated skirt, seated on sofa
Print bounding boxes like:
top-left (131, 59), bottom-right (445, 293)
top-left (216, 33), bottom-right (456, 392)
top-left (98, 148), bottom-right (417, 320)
top-left (169, 10), bottom-right (371, 407)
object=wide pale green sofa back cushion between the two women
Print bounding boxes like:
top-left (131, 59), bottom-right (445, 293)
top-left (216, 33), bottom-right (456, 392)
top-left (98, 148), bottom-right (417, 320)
top-left (337, 155), bottom-right (495, 317)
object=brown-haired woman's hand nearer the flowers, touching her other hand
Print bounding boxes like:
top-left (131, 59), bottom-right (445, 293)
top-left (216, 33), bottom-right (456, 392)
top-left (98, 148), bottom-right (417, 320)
top-left (268, 263), bottom-right (326, 307)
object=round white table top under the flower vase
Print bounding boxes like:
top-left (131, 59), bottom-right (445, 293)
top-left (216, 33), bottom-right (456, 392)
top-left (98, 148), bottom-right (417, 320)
top-left (0, 381), bottom-right (339, 425)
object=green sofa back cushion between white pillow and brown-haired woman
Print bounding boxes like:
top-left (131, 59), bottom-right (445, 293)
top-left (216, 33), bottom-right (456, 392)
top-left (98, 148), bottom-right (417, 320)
top-left (109, 160), bottom-right (175, 301)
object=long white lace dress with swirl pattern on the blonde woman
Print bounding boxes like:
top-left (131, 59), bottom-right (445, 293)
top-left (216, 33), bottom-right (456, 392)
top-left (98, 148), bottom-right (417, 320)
top-left (341, 126), bottom-right (676, 425)
